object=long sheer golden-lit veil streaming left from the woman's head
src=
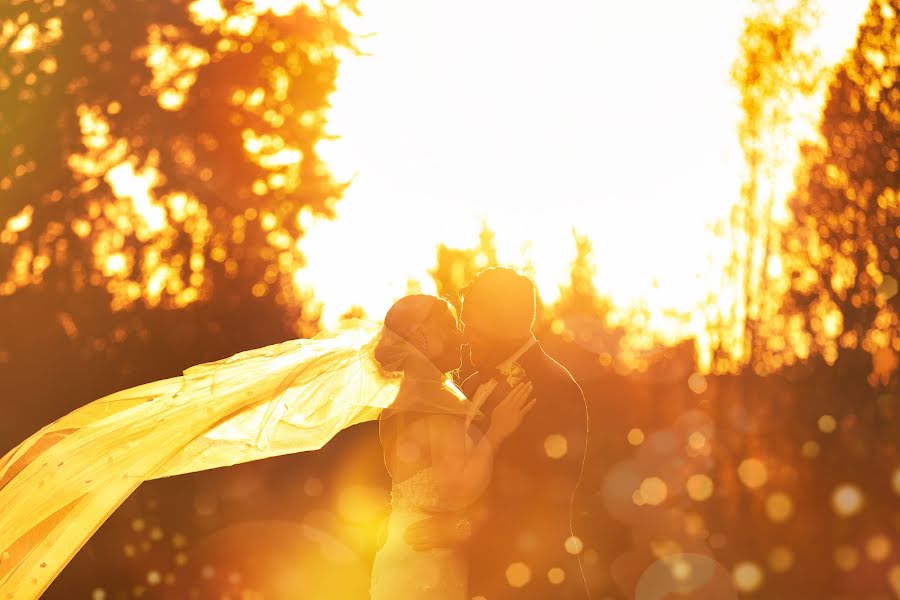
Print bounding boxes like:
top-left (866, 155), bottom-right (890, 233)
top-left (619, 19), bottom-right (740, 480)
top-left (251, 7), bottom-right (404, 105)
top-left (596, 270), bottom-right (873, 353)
top-left (0, 319), bottom-right (480, 600)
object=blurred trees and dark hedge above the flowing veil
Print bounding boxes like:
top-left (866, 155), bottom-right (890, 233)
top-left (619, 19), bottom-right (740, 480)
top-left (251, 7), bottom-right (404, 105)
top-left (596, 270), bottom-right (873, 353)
top-left (0, 0), bottom-right (354, 440)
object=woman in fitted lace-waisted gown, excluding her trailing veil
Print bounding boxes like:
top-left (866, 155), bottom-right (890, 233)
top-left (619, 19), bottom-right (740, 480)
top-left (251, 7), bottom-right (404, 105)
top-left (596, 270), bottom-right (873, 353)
top-left (370, 296), bottom-right (534, 600)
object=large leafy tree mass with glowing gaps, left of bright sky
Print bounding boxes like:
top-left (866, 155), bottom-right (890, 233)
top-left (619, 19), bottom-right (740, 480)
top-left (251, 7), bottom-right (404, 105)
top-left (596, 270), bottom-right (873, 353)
top-left (0, 0), bottom-right (353, 326)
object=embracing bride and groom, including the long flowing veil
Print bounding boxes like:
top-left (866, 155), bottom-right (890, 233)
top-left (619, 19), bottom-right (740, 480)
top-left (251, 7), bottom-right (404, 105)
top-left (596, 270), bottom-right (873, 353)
top-left (0, 268), bottom-right (589, 600)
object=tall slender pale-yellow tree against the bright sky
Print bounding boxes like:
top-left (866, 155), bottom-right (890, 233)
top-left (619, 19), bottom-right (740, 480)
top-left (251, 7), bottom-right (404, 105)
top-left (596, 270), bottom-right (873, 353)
top-left (724, 0), bottom-right (823, 374)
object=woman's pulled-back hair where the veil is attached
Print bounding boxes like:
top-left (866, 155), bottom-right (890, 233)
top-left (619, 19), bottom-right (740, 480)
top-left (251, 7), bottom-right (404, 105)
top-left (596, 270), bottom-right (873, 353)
top-left (374, 294), bottom-right (455, 373)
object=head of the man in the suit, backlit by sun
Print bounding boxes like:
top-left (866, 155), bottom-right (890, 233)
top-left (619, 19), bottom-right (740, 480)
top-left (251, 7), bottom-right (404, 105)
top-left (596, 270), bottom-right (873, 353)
top-left (460, 267), bottom-right (535, 369)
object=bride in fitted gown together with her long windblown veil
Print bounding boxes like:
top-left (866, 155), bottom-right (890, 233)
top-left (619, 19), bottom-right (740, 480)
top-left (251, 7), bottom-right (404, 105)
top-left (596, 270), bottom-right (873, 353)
top-left (0, 295), bottom-right (533, 600)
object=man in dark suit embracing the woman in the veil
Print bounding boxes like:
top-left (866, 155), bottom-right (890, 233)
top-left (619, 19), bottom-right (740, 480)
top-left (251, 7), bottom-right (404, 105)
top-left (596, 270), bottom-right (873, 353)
top-left (406, 268), bottom-right (588, 600)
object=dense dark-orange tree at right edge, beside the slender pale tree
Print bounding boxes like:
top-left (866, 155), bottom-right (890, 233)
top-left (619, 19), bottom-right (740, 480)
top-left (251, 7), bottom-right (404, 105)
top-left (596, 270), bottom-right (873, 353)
top-left (781, 0), bottom-right (900, 385)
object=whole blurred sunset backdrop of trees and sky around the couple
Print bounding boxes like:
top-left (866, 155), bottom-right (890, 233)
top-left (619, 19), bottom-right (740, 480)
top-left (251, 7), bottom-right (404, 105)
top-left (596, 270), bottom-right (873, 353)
top-left (0, 0), bottom-right (900, 600)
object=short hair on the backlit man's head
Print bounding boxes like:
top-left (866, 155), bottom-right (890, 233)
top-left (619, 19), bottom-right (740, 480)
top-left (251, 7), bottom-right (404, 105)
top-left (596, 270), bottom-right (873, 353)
top-left (460, 267), bottom-right (537, 337)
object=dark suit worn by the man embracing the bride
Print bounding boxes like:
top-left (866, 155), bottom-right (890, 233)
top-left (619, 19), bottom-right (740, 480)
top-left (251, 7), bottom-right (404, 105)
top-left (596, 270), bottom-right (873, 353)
top-left (463, 343), bottom-right (588, 600)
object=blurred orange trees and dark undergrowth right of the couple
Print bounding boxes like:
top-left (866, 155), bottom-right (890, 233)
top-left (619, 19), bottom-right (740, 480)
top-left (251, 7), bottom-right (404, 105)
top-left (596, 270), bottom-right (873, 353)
top-left (433, 0), bottom-right (900, 598)
